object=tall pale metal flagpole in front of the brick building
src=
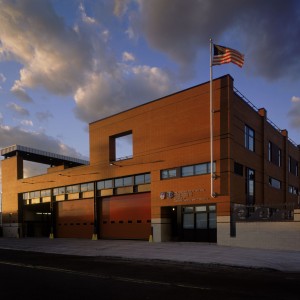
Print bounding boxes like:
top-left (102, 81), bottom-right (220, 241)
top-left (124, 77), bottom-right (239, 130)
top-left (209, 39), bottom-right (215, 198)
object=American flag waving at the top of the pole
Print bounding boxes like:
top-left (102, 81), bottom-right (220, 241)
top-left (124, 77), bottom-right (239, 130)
top-left (212, 45), bottom-right (244, 67)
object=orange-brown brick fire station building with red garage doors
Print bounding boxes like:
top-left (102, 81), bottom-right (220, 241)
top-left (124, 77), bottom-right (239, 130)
top-left (1, 75), bottom-right (300, 243)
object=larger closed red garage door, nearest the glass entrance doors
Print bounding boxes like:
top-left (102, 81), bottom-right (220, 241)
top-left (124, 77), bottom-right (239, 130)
top-left (100, 193), bottom-right (151, 239)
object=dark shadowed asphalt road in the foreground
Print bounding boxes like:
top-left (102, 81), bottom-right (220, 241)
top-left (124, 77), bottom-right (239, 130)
top-left (0, 249), bottom-right (300, 300)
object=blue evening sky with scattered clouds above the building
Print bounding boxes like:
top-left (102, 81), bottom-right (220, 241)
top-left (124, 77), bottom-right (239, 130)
top-left (0, 0), bottom-right (300, 188)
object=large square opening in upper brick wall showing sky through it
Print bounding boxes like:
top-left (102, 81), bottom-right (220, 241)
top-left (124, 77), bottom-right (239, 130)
top-left (109, 131), bottom-right (133, 161)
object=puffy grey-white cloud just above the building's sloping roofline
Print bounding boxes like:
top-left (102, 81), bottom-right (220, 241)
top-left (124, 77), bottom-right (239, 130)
top-left (75, 65), bottom-right (174, 122)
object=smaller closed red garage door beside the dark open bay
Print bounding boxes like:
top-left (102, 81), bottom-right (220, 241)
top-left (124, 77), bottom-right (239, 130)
top-left (55, 199), bottom-right (94, 238)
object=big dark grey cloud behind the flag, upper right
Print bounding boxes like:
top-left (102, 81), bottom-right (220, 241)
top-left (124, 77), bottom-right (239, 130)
top-left (131, 0), bottom-right (300, 79)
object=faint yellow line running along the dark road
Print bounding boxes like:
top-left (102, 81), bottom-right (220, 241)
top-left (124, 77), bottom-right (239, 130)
top-left (0, 261), bottom-right (211, 290)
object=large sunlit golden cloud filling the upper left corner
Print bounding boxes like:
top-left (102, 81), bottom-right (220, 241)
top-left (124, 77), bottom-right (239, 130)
top-left (0, 0), bottom-right (93, 98)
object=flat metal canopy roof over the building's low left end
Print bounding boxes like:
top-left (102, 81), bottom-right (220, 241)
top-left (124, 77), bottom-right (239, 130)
top-left (0, 145), bottom-right (89, 167)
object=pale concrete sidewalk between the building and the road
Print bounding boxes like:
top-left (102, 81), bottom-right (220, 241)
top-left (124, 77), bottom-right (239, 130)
top-left (0, 238), bottom-right (300, 272)
